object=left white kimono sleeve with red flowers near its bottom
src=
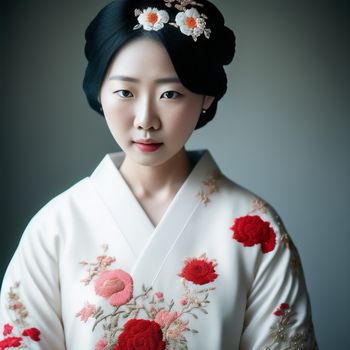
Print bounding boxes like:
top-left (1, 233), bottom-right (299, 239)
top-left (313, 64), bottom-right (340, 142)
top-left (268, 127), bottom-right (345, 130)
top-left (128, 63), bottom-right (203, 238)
top-left (0, 214), bottom-right (65, 350)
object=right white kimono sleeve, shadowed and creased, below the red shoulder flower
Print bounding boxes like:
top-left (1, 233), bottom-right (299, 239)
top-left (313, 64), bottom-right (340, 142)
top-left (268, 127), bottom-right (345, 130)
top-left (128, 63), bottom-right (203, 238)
top-left (240, 209), bottom-right (318, 350)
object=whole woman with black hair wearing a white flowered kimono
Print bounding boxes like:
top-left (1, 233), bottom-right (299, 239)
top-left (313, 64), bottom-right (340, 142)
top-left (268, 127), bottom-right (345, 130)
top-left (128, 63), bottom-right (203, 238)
top-left (0, 0), bottom-right (317, 350)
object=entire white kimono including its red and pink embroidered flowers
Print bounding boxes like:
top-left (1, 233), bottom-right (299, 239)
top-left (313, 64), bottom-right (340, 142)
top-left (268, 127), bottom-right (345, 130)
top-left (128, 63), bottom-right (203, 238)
top-left (0, 151), bottom-right (317, 350)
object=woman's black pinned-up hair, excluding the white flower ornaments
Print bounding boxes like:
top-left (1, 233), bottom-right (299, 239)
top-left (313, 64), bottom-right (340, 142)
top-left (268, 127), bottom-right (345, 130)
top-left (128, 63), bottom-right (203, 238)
top-left (83, 0), bottom-right (235, 129)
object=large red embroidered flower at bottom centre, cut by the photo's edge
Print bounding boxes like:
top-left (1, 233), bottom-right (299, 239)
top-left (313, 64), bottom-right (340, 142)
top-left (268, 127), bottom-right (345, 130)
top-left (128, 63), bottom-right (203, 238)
top-left (113, 319), bottom-right (165, 350)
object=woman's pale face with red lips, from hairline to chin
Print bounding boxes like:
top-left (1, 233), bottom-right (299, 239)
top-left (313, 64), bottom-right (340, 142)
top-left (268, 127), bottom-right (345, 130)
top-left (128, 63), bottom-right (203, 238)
top-left (100, 39), bottom-right (214, 166)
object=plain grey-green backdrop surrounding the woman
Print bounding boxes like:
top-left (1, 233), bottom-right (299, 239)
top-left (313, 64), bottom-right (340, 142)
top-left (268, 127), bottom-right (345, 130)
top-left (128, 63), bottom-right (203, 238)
top-left (0, 0), bottom-right (350, 349)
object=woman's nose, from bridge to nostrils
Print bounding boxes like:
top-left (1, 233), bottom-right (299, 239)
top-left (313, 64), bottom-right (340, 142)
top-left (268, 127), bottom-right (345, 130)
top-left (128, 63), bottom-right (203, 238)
top-left (134, 99), bottom-right (160, 130)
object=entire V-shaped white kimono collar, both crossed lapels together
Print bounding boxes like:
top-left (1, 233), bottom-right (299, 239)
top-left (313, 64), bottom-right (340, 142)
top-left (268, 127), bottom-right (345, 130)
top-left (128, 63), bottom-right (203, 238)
top-left (90, 151), bottom-right (218, 286)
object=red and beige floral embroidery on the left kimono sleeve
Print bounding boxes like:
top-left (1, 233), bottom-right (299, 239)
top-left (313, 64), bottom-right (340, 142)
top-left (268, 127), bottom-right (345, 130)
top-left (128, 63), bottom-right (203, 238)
top-left (0, 282), bottom-right (40, 350)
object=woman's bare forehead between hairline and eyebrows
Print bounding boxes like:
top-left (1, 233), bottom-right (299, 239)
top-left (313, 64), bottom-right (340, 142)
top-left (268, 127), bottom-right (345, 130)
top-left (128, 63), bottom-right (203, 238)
top-left (107, 38), bottom-right (177, 78)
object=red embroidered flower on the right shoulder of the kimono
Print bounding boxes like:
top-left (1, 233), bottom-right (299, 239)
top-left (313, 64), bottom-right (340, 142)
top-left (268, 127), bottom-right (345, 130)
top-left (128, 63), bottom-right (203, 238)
top-left (230, 215), bottom-right (276, 253)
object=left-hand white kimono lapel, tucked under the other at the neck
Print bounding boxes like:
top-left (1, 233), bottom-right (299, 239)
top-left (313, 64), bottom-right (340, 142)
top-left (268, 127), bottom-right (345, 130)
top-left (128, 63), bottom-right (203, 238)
top-left (90, 152), bottom-right (154, 259)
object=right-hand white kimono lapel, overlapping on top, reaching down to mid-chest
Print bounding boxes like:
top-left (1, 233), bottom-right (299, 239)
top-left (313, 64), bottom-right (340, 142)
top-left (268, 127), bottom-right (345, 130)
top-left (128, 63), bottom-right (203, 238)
top-left (131, 151), bottom-right (218, 286)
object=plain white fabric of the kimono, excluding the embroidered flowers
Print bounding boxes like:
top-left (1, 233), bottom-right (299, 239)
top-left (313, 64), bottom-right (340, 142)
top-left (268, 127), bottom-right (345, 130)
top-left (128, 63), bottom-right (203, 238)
top-left (0, 151), bottom-right (314, 350)
